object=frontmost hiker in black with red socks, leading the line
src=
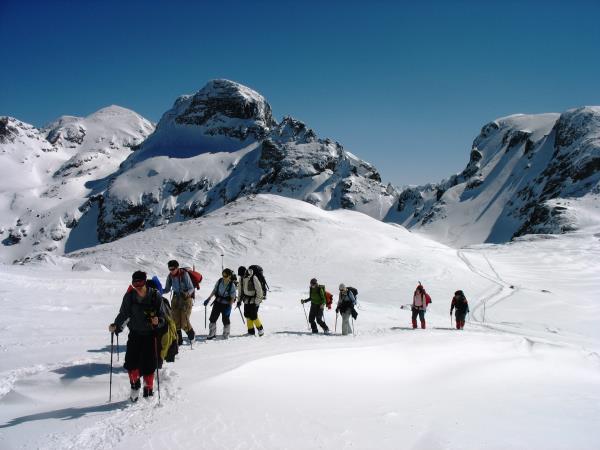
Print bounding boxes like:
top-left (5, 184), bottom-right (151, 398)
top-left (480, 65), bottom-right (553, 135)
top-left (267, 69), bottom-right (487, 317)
top-left (108, 271), bottom-right (165, 402)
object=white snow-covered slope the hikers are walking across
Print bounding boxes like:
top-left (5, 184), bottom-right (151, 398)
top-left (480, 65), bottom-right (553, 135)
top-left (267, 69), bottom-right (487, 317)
top-left (0, 195), bottom-right (600, 450)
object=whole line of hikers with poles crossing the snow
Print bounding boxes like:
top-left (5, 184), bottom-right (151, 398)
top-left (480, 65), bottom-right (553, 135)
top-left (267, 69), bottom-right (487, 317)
top-left (108, 260), bottom-right (469, 402)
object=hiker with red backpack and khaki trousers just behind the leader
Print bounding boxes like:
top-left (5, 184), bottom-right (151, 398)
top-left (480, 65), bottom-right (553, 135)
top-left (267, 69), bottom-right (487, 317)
top-left (164, 259), bottom-right (196, 345)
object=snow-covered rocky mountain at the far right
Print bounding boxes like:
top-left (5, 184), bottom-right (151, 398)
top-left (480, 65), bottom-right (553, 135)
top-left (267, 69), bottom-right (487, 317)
top-left (388, 106), bottom-right (600, 246)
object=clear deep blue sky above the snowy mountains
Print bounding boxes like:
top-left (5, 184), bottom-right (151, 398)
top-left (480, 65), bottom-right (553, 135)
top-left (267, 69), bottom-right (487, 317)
top-left (0, 0), bottom-right (600, 185)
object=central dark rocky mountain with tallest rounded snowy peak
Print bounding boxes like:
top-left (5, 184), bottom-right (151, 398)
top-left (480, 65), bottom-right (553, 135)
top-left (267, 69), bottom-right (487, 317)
top-left (97, 80), bottom-right (396, 242)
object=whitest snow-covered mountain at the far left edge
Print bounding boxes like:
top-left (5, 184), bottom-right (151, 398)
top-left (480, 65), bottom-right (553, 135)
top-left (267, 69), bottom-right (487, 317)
top-left (0, 106), bottom-right (154, 262)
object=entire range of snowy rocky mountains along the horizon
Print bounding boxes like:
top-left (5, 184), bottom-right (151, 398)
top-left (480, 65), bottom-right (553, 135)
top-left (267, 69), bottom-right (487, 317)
top-left (0, 80), bottom-right (600, 262)
